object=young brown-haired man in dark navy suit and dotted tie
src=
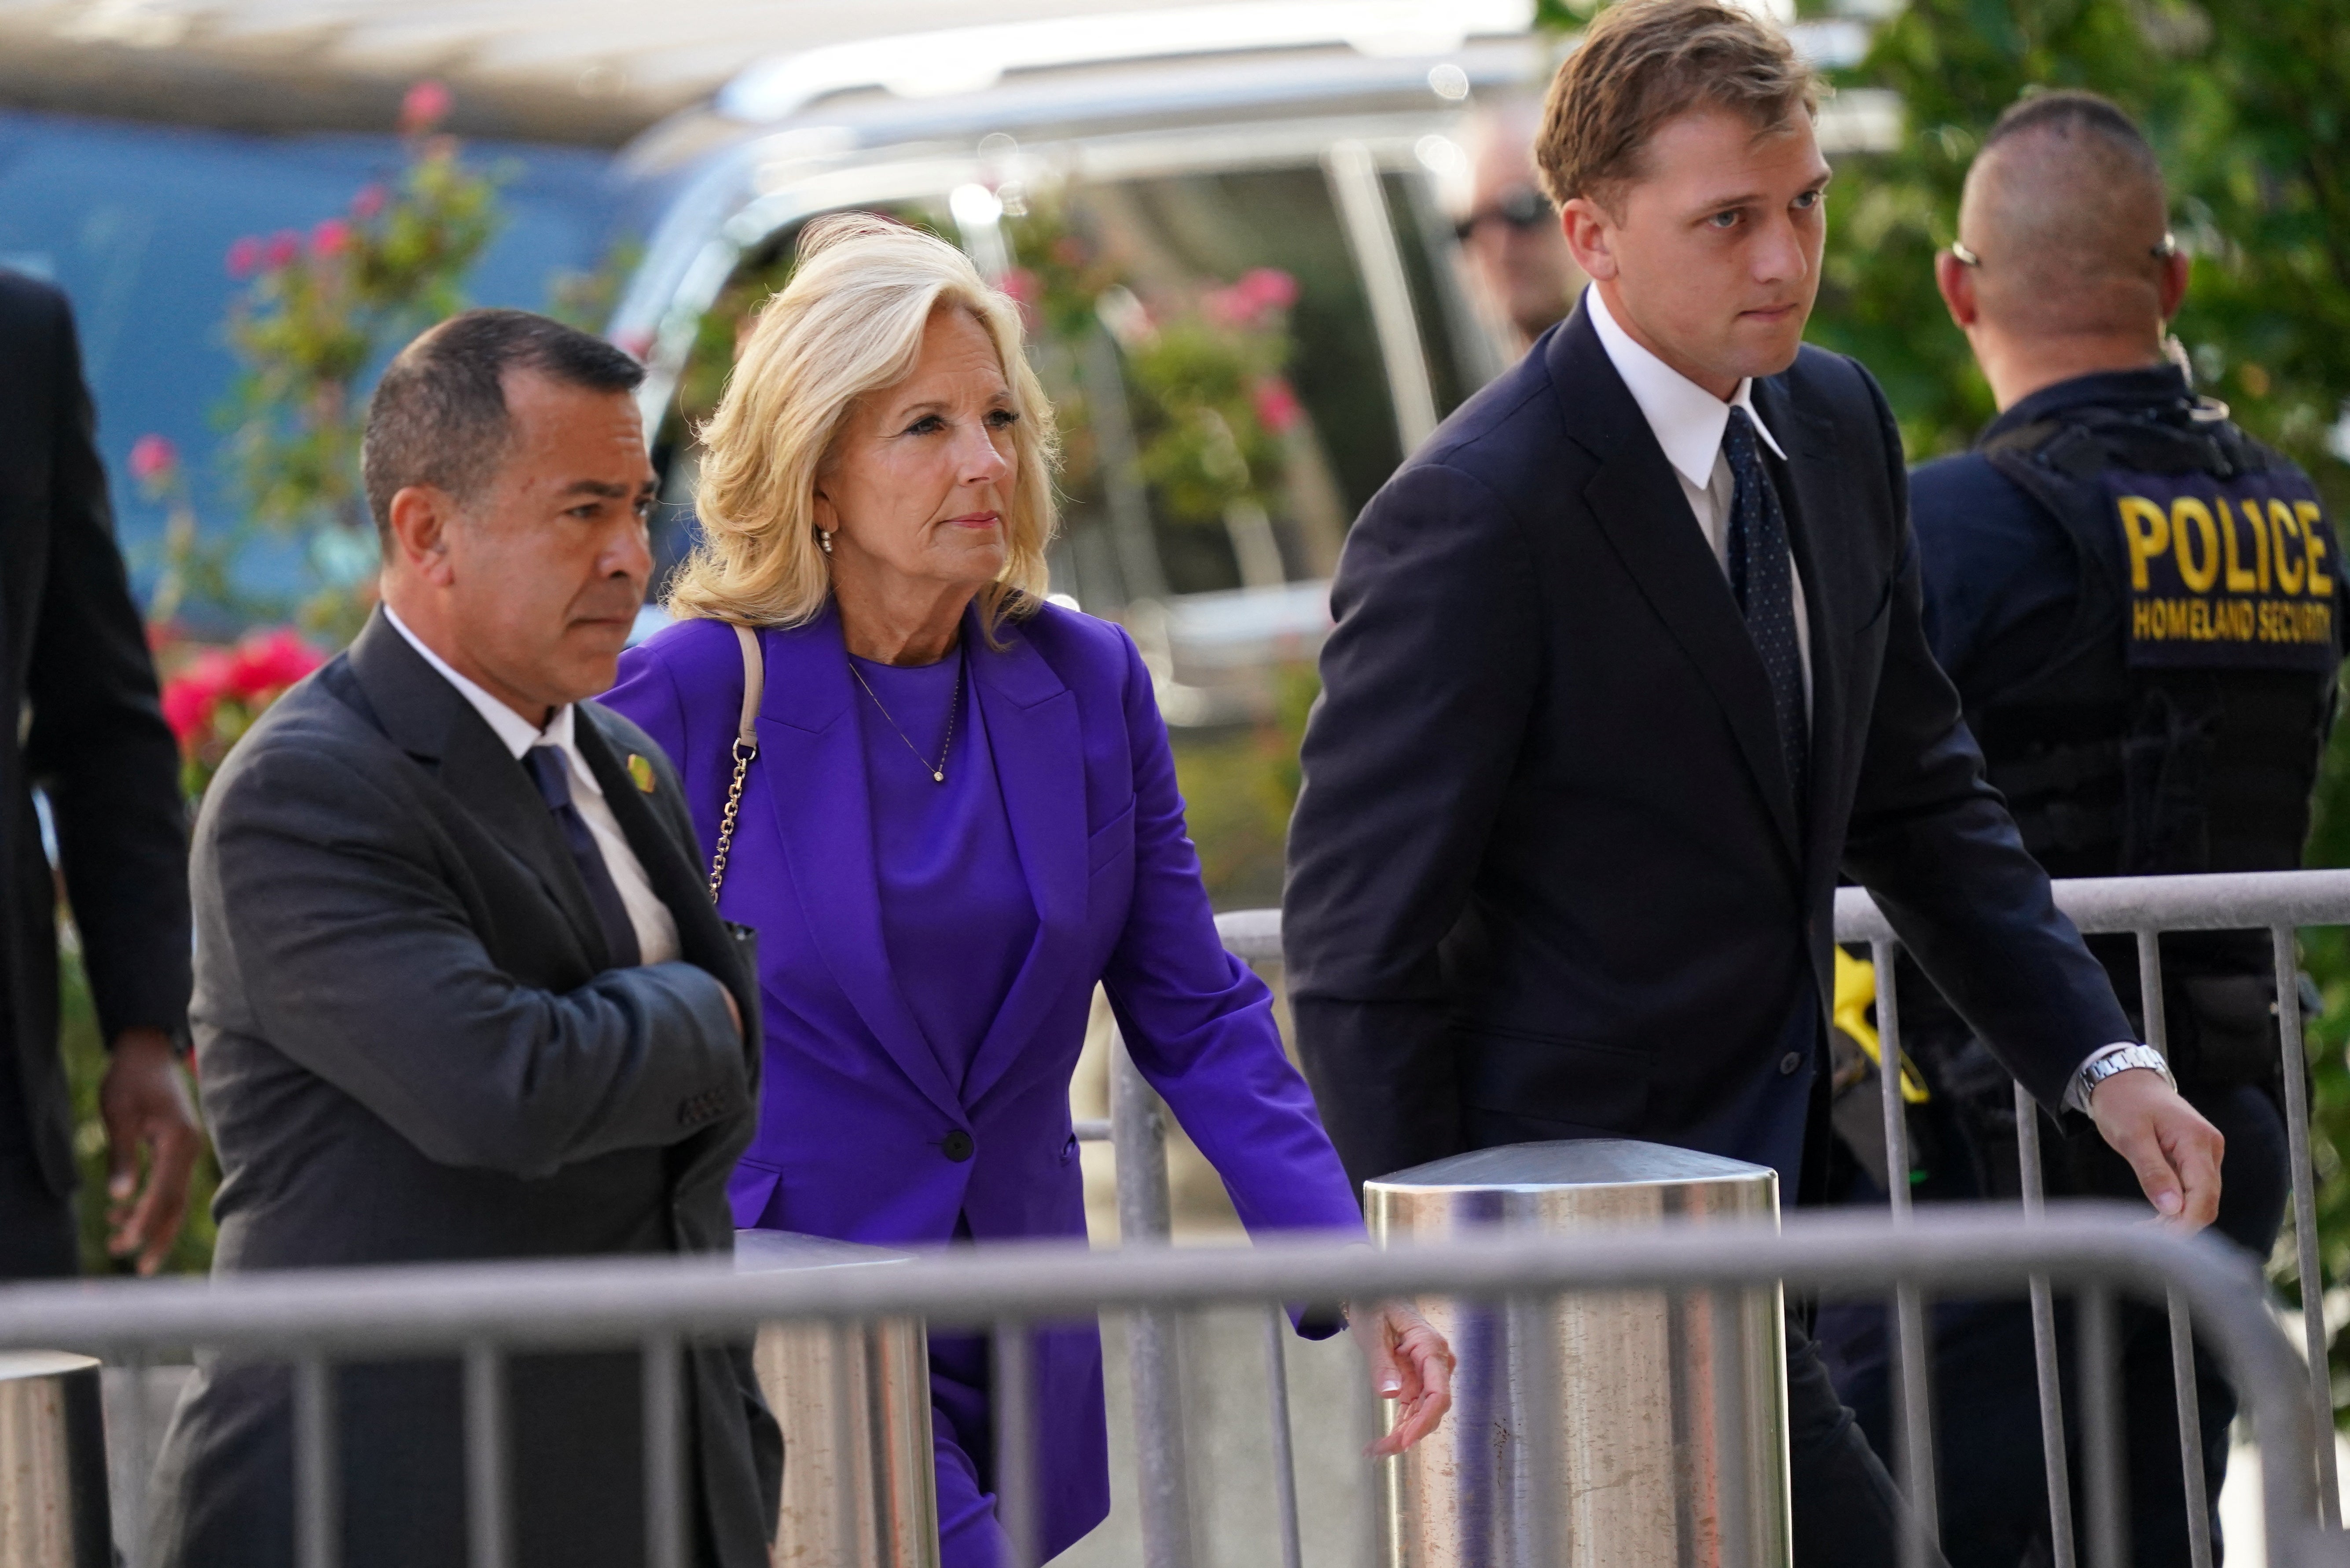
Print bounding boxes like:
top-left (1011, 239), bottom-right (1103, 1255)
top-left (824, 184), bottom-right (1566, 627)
top-left (1283, 0), bottom-right (2221, 1566)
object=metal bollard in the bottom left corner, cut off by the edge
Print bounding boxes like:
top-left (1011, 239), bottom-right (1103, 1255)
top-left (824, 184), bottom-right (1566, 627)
top-left (0, 1349), bottom-right (115, 1568)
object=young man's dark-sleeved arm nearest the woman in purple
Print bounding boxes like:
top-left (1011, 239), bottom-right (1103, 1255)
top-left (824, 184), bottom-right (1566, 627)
top-left (1283, 463), bottom-right (1542, 1182)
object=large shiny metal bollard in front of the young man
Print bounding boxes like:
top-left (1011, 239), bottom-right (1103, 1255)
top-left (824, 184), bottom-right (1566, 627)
top-left (1363, 1138), bottom-right (1791, 1568)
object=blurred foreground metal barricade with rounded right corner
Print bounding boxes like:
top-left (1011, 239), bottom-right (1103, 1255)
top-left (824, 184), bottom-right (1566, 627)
top-left (0, 1206), bottom-right (2350, 1568)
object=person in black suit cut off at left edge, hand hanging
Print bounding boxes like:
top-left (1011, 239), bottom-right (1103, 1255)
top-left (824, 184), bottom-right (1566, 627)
top-left (0, 270), bottom-right (202, 1281)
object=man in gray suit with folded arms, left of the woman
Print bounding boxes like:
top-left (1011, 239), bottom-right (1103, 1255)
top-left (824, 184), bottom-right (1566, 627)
top-left (158, 310), bottom-right (782, 1568)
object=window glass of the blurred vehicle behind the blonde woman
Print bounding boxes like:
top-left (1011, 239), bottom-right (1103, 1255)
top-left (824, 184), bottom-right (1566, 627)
top-left (663, 165), bottom-right (1403, 613)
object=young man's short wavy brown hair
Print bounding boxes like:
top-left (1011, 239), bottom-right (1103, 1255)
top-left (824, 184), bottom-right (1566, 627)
top-left (1535, 0), bottom-right (1819, 207)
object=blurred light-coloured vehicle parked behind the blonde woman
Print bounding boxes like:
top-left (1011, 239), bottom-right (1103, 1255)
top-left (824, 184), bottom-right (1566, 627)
top-left (613, 0), bottom-right (1882, 727)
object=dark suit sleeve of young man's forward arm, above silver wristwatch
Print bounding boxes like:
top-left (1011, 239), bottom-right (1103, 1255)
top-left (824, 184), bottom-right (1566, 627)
top-left (1845, 383), bottom-right (2131, 1112)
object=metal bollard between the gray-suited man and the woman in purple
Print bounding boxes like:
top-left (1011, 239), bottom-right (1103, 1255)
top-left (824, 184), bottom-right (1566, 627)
top-left (735, 1230), bottom-right (938, 1568)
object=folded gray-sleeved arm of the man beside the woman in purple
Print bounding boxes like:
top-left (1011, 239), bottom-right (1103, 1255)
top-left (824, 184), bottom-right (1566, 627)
top-left (213, 745), bottom-right (747, 1175)
